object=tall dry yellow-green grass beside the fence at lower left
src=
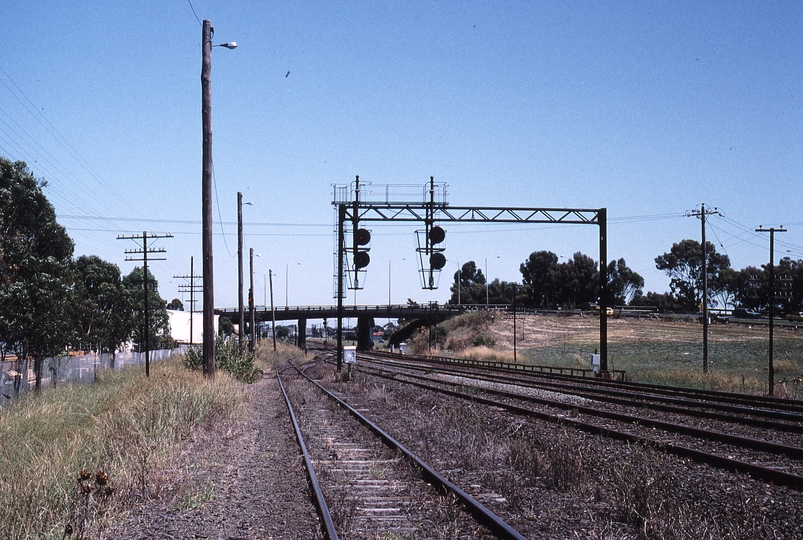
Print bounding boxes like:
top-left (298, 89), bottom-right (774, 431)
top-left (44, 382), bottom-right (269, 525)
top-left (0, 359), bottom-right (246, 538)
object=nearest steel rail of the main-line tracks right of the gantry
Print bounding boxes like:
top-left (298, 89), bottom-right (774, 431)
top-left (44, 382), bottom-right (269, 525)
top-left (356, 360), bottom-right (803, 491)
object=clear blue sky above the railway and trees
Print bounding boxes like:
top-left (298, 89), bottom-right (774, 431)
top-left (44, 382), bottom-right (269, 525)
top-left (0, 0), bottom-right (803, 307)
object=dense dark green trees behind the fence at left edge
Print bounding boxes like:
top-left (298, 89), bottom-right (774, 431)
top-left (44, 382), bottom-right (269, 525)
top-left (0, 157), bottom-right (171, 388)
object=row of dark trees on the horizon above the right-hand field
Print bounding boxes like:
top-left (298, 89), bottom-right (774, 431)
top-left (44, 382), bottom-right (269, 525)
top-left (449, 239), bottom-right (803, 314)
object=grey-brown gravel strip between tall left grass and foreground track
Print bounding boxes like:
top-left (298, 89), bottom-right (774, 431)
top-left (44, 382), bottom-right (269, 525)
top-left (98, 374), bottom-right (321, 540)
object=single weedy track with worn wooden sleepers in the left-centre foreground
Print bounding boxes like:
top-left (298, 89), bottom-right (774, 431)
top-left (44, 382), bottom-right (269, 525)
top-left (278, 358), bottom-right (524, 540)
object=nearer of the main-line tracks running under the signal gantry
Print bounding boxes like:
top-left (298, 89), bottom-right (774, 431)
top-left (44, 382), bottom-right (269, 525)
top-left (352, 355), bottom-right (803, 491)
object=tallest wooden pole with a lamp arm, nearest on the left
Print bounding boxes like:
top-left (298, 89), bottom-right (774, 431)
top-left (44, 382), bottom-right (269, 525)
top-left (201, 20), bottom-right (237, 377)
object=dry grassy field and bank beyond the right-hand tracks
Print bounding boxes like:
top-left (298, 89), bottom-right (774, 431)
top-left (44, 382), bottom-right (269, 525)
top-left (412, 313), bottom-right (803, 399)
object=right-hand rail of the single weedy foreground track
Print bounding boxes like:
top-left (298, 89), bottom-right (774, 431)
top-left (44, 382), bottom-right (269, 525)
top-left (290, 363), bottom-right (525, 540)
